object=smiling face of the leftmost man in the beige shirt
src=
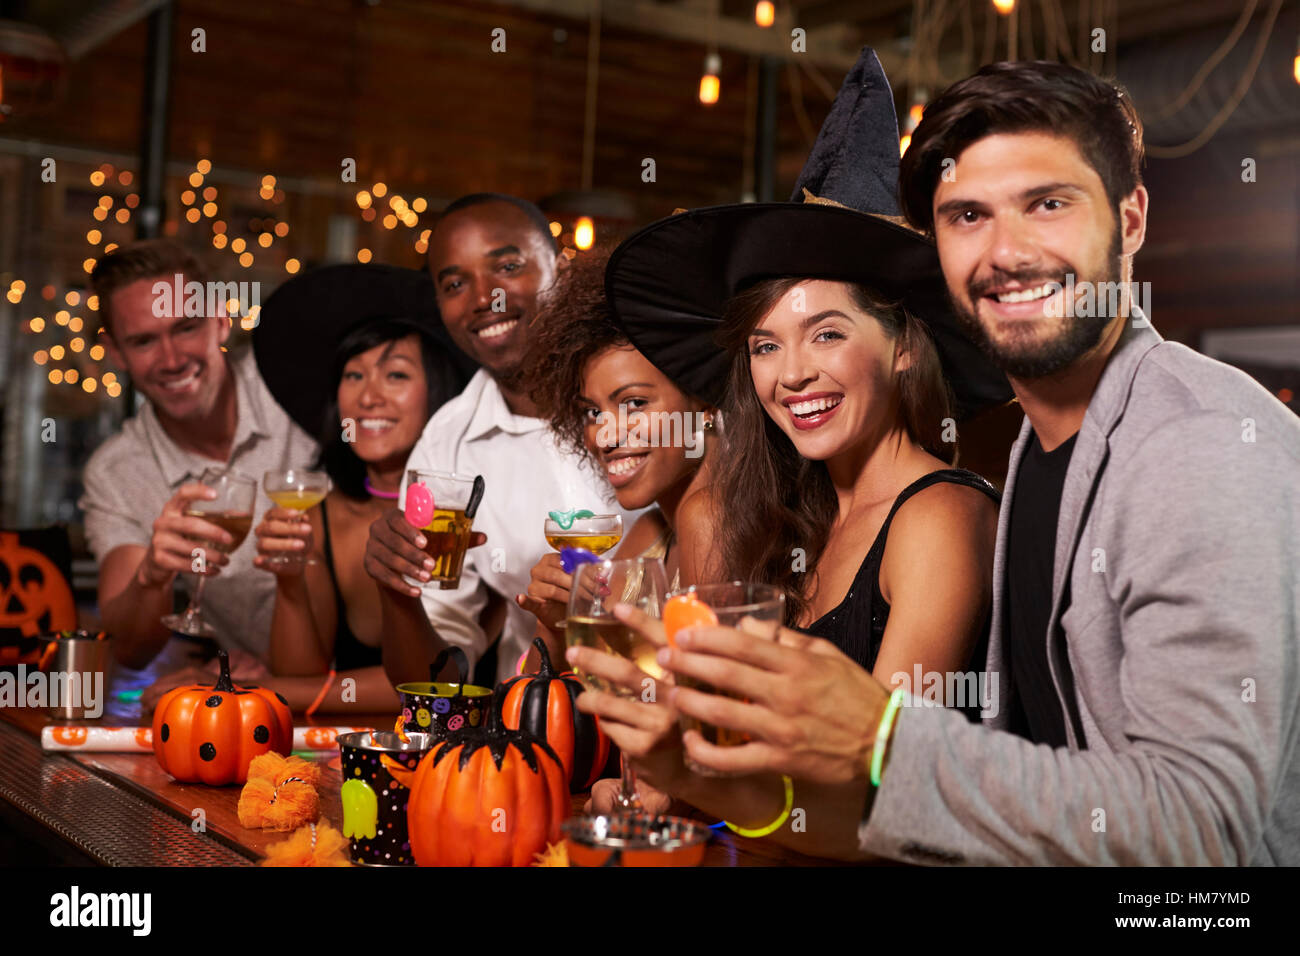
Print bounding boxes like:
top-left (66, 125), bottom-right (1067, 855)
top-left (105, 276), bottom-right (230, 423)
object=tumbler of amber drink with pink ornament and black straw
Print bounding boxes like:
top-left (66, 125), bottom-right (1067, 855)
top-left (402, 468), bottom-right (484, 591)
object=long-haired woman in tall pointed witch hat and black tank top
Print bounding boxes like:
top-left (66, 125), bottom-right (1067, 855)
top-left (571, 49), bottom-right (1011, 822)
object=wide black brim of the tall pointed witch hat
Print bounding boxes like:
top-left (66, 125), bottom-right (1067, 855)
top-left (605, 203), bottom-right (1011, 419)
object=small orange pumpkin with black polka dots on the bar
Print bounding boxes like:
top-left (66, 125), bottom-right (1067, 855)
top-left (153, 650), bottom-right (294, 787)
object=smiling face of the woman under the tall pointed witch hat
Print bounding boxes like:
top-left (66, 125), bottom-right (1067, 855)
top-left (748, 281), bottom-right (909, 460)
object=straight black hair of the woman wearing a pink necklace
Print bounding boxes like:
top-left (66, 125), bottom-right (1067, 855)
top-left (315, 317), bottom-right (463, 501)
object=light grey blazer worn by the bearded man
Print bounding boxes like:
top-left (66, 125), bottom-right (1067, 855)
top-left (858, 316), bottom-right (1300, 866)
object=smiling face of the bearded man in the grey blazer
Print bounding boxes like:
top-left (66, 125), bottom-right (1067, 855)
top-left (933, 133), bottom-right (1145, 378)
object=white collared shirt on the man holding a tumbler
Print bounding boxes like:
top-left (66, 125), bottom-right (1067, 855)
top-left (402, 369), bottom-right (641, 680)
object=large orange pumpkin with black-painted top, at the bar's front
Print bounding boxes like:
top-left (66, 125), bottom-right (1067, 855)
top-left (380, 691), bottom-right (571, 866)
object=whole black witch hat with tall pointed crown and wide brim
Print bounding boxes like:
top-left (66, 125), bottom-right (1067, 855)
top-left (605, 47), bottom-right (1011, 419)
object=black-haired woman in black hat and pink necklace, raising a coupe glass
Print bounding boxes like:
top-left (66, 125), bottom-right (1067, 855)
top-left (246, 264), bottom-right (475, 713)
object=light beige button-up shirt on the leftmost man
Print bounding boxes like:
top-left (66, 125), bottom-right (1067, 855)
top-left (79, 351), bottom-right (317, 661)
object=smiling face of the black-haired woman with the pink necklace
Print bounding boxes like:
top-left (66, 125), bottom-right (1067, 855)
top-left (338, 334), bottom-right (429, 470)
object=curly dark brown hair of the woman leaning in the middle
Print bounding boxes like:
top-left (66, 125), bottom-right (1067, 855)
top-left (524, 246), bottom-right (631, 468)
